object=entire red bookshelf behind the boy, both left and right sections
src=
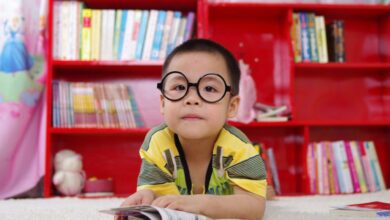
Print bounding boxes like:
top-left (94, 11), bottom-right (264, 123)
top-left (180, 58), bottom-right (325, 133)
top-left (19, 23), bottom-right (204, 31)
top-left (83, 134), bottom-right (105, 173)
top-left (44, 0), bottom-right (390, 197)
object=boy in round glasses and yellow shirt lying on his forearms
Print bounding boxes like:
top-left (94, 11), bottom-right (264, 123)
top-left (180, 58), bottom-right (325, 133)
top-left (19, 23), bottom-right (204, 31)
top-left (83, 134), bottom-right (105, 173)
top-left (122, 39), bottom-right (267, 219)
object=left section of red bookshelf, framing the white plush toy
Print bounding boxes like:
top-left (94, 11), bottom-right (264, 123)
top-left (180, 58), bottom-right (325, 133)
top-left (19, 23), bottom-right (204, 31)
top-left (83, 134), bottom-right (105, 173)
top-left (44, 0), bottom-right (198, 197)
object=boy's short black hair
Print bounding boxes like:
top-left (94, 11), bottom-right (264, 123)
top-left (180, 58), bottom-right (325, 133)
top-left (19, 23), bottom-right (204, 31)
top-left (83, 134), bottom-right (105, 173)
top-left (162, 38), bottom-right (241, 95)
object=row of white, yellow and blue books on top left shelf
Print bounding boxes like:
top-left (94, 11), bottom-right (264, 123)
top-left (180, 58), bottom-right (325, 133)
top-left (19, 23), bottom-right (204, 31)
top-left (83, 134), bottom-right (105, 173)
top-left (53, 1), bottom-right (195, 61)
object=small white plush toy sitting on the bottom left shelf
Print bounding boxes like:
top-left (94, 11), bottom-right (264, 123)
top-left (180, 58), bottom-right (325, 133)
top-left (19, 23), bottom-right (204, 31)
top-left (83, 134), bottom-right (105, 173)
top-left (53, 150), bottom-right (85, 196)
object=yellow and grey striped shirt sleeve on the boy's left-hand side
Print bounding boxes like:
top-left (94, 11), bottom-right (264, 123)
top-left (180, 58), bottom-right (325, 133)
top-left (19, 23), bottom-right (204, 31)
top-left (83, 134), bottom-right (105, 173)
top-left (137, 144), bottom-right (180, 196)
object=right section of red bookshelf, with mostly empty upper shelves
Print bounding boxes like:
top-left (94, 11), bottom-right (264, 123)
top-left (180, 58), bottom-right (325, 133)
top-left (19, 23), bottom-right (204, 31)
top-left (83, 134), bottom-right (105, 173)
top-left (198, 1), bottom-right (390, 195)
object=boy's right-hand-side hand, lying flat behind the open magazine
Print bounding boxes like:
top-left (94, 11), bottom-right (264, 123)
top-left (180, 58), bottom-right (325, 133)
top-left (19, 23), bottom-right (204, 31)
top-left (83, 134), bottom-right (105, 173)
top-left (152, 195), bottom-right (205, 214)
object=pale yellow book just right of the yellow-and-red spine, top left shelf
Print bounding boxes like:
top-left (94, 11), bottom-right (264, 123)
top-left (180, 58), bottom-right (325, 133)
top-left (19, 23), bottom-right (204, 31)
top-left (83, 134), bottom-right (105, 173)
top-left (91, 10), bottom-right (102, 60)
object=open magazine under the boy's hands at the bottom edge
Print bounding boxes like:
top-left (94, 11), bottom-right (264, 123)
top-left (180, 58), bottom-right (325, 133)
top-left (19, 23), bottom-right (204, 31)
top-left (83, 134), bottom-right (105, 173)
top-left (100, 205), bottom-right (210, 220)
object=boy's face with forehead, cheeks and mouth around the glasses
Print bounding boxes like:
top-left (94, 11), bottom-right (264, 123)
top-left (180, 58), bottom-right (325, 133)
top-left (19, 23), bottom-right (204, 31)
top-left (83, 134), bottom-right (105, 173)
top-left (160, 52), bottom-right (239, 139)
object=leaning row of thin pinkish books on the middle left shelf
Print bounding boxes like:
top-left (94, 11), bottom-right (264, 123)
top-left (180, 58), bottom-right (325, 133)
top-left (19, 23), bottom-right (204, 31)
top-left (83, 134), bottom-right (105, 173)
top-left (52, 81), bottom-right (144, 128)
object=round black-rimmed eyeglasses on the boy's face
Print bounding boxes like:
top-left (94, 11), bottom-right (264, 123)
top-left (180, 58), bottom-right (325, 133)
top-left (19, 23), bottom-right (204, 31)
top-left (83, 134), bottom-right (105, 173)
top-left (157, 71), bottom-right (232, 103)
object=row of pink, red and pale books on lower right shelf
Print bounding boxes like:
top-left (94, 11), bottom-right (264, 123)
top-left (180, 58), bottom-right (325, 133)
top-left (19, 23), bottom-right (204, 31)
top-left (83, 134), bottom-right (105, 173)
top-left (307, 141), bottom-right (386, 194)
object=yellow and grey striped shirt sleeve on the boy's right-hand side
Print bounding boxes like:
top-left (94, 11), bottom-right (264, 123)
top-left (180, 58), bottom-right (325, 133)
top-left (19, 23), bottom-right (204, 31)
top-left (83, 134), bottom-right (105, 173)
top-left (226, 147), bottom-right (267, 198)
